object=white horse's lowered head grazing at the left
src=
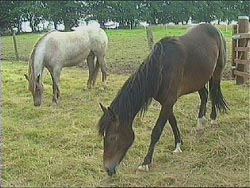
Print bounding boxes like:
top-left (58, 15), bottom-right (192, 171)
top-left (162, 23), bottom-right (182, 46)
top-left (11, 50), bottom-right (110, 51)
top-left (24, 74), bottom-right (43, 106)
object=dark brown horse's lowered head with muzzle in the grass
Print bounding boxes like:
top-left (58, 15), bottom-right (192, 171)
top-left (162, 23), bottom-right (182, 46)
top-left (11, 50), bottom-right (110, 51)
top-left (99, 104), bottom-right (134, 176)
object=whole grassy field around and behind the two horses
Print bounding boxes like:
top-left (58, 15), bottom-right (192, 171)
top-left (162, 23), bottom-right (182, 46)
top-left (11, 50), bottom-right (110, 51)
top-left (1, 28), bottom-right (250, 187)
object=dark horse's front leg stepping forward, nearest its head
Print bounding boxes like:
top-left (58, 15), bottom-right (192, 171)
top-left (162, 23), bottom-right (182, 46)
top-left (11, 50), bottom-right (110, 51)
top-left (138, 107), bottom-right (172, 171)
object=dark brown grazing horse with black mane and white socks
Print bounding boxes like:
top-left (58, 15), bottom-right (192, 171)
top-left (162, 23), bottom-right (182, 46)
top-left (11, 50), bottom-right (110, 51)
top-left (98, 24), bottom-right (228, 176)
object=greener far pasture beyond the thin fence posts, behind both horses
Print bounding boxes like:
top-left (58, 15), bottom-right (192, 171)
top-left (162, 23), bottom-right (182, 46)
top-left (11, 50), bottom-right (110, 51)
top-left (1, 28), bottom-right (232, 76)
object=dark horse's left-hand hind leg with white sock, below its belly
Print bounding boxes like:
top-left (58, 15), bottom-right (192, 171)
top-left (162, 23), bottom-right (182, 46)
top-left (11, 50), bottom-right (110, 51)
top-left (197, 86), bottom-right (208, 129)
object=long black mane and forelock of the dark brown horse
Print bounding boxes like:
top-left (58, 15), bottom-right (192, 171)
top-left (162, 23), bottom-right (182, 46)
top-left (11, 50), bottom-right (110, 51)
top-left (98, 42), bottom-right (166, 135)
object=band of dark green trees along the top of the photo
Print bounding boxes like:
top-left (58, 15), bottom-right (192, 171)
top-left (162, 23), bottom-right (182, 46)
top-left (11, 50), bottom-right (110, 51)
top-left (0, 1), bottom-right (250, 32)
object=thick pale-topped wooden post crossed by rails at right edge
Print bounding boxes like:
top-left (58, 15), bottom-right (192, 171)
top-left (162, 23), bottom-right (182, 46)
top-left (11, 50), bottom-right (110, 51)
top-left (236, 16), bottom-right (249, 84)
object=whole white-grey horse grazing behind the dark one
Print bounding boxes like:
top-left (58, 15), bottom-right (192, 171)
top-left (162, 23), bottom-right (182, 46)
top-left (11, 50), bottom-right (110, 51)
top-left (25, 26), bottom-right (108, 106)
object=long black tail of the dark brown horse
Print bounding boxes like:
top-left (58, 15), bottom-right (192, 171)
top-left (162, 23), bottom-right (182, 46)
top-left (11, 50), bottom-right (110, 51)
top-left (209, 30), bottom-right (229, 112)
